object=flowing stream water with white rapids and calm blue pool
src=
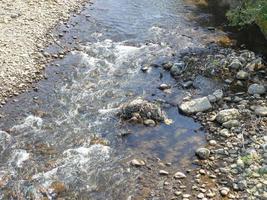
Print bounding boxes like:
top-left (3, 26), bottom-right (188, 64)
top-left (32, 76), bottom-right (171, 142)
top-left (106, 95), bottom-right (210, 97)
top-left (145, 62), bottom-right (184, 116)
top-left (0, 0), bottom-right (224, 199)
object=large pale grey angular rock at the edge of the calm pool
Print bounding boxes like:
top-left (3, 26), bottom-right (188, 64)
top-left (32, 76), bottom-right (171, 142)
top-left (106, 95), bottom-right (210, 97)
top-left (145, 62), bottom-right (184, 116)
top-left (179, 97), bottom-right (212, 114)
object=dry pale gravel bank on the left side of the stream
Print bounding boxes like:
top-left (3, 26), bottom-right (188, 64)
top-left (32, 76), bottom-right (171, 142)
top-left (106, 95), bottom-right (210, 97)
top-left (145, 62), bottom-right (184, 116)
top-left (0, 0), bottom-right (89, 104)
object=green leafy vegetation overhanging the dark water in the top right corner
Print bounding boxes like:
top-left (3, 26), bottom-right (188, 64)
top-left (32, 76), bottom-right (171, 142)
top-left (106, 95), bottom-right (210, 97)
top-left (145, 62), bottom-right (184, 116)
top-left (227, 0), bottom-right (267, 38)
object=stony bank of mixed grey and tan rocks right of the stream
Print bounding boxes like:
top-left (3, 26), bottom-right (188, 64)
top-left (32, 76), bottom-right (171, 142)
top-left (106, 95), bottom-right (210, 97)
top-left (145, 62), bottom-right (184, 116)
top-left (130, 46), bottom-right (267, 200)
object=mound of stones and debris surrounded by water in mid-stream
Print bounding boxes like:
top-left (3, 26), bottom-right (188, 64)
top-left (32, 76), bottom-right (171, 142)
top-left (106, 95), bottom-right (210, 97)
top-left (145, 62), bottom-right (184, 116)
top-left (119, 98), bottom-right (166, 124)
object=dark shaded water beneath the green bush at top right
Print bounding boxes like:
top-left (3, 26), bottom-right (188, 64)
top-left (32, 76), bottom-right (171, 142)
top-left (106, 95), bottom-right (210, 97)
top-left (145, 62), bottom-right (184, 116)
top-left (186, 0), bottom-right (267, 59)
